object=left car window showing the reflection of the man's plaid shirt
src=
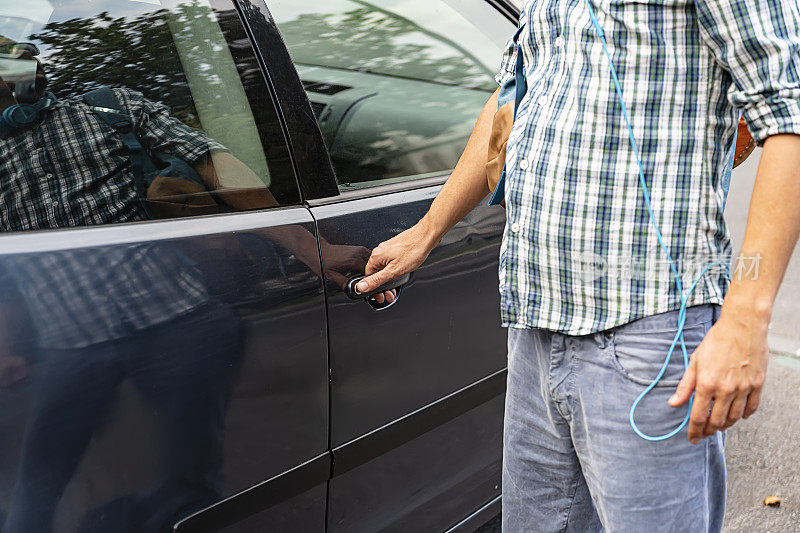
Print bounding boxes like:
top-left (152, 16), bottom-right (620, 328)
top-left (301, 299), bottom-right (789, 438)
top-left (0, 0), bottom-right (299, 231)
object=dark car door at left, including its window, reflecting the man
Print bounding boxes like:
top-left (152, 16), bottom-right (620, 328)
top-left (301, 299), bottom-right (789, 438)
top-left (0, 0), bottom-right (328, 532)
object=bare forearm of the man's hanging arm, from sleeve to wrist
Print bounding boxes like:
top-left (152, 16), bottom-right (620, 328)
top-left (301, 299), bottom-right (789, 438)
top-left (722, 135), bottom-right (800, 326)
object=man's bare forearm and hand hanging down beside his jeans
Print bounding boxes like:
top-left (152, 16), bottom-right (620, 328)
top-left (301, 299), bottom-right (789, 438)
top-left (669, 134), bottom-right (800, 443)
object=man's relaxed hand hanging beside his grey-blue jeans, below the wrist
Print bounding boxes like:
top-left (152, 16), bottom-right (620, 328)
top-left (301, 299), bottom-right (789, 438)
top-left (669, 307), bottom-right (769, 444)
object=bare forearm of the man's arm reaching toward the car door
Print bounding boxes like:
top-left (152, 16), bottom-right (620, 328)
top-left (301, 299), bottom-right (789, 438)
top-left (420, 91), bottom-right (497, 249)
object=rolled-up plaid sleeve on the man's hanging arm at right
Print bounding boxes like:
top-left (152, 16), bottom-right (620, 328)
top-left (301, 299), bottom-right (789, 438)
top-left (696, 0), bottom-right (800, 144)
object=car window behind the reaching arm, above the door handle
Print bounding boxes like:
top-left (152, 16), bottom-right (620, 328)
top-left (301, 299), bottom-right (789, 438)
top-left (268, 0), bottom-right (506, 190)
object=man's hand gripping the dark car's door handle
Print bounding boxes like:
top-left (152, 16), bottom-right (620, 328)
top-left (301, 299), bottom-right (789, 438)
top-left (356, 219), bottom-right (438, 292)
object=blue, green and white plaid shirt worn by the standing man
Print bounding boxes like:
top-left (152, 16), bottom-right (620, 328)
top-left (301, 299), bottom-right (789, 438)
top-left (497, 0), bottom-right (800, 335)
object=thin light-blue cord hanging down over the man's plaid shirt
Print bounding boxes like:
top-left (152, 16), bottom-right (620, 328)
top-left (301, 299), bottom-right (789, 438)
top-left (584, 0), bottom-right (730, 441)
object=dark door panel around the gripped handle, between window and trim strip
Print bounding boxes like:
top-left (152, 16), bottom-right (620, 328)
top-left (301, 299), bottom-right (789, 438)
top-left (312, 187), bottom-right (506, 448)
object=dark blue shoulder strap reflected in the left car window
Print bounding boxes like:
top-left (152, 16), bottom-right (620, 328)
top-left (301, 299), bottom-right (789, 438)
top-left (83, 87), bottom-right (154, 218)
